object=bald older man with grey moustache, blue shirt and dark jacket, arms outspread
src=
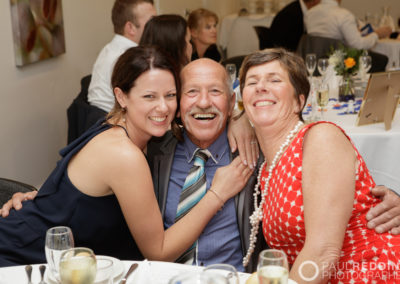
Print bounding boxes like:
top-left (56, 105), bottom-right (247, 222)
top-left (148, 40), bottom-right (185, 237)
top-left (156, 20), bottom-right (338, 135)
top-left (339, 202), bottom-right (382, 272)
top-left (0, 58), bottom-right (400, 272)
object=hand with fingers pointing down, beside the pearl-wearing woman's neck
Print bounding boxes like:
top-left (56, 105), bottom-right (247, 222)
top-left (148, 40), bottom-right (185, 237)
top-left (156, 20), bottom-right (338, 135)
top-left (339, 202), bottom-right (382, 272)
top-left (228, 113), bottom-right (259, 169)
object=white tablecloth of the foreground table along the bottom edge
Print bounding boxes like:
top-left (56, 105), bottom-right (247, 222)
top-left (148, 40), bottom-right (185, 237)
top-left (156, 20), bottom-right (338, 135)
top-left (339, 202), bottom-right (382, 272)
top-left (0, 257), bottom-right (250, 284)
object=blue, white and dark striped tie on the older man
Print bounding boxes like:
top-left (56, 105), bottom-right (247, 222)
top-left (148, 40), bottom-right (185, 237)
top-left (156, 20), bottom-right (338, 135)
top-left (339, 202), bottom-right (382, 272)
top-left (175, 149), bottom-right (211, 264)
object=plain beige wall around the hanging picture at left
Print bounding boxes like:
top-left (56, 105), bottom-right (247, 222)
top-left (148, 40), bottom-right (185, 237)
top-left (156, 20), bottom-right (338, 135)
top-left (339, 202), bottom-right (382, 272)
top-left (0, 0), bottom-right (113, 186)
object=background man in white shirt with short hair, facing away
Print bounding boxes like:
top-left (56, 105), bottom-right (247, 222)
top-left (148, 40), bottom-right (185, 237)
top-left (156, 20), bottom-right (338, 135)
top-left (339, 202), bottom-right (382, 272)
top-left (88, 0), bottom-right (156, 113)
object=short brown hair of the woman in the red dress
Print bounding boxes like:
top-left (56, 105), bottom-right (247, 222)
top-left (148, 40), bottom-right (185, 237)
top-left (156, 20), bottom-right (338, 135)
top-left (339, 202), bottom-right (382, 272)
top-left (239, 48), bottom-right (310, 121)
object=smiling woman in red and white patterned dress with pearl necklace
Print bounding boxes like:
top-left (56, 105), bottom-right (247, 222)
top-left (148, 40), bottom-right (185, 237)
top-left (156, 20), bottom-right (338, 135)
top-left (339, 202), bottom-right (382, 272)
top-left (240, 49), bottom-right (400, 283)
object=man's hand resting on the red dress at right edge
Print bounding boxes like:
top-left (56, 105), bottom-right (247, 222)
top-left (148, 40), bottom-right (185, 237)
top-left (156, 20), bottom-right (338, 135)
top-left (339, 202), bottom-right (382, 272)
top-left (367, 185), bottom-right (400, 235)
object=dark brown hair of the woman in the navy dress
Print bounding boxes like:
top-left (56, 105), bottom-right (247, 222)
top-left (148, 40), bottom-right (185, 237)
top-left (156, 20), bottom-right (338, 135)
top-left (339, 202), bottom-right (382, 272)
top-left (107, 46), bottom-right (181, 131)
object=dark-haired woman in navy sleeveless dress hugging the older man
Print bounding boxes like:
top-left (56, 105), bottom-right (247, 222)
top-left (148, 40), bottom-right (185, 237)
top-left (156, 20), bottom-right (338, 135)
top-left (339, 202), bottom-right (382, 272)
top-left (0, 47), bottom-right (252, 266)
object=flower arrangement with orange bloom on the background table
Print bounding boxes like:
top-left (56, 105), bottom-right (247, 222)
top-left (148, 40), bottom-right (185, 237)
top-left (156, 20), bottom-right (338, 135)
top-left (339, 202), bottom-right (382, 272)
top-left (329, 45), bottom-right (363, 76)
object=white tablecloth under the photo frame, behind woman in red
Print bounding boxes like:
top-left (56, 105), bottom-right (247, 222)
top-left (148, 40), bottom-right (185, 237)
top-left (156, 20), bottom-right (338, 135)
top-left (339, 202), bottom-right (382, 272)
top-left (304, 101), bottom-right (400, 193)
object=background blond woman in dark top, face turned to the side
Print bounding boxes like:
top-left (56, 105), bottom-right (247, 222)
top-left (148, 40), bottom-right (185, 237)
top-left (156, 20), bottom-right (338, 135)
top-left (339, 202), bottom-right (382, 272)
top-left (188, 8), bottom-right (221, 62)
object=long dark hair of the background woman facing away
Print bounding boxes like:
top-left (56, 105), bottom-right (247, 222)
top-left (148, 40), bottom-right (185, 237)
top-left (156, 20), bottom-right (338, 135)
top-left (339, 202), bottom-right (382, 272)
top-left (139, 14), bottom-right (189, 67)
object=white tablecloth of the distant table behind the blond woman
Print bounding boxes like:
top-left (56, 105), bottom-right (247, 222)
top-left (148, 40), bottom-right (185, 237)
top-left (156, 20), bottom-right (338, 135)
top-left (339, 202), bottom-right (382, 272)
top-left (218, 14), bottom-right (274, 58)
